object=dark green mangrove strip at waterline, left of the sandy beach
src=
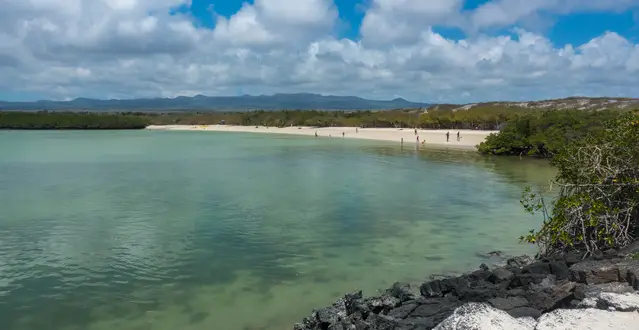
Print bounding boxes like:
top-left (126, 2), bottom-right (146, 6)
top-left (0, 112), bottom-right (149, 129)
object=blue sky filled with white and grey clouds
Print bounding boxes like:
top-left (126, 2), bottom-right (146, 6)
top-left (0, 0), bottom-right (639, 103)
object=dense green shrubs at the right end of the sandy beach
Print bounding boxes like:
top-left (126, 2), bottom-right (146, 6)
top-left (478, 110), bottom-right (619, 157)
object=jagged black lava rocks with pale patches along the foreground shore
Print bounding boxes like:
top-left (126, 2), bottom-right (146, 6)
top-left (294, 253), bottom-right (639, 330)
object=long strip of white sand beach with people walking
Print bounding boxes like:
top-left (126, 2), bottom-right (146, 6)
top-left (147, 125), bottom-right (498, 149)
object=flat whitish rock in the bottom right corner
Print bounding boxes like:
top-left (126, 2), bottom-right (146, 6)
top-left (536, 309), bottom-right (639, 330)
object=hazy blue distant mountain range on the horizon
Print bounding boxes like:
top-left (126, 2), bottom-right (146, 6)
top-left (0, 93), bottom-right (430, 111)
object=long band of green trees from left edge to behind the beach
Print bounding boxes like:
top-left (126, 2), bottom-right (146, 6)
top-left (0, 106), bottom-right (533, 130)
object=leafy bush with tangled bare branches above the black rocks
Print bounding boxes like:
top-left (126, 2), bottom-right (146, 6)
top-left (522, 112), bottom-right (639, 254)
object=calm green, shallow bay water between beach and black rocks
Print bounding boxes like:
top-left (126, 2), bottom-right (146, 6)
top-left (0, 131), bottom-right (553, 330)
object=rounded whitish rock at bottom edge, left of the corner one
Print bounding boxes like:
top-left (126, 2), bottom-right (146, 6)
top-left (434, 303), bottom-right (536, 330)
